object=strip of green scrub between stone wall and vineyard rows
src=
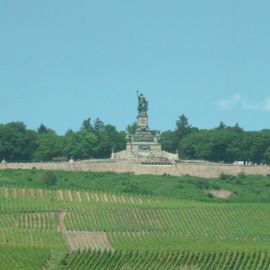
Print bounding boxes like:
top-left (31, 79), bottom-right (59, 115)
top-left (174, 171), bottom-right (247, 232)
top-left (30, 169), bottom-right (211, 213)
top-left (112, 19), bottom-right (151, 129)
top-left (0, 170), bottom-right (270, 203)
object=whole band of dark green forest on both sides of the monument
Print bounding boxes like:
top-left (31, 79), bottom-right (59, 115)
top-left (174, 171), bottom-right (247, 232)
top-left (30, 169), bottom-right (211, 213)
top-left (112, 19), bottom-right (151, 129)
top-left (0, 114), bottom-right (270, 164)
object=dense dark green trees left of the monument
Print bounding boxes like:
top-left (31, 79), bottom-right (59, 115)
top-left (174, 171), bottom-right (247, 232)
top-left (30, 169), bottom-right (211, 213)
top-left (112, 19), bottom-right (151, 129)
top-left (0, 118), bottom-right (126, 161)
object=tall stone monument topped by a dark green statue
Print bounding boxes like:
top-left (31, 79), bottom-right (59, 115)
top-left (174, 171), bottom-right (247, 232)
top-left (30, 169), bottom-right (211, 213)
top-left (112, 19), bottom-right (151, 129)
top-left (112, 91), bottom-right (178, 164)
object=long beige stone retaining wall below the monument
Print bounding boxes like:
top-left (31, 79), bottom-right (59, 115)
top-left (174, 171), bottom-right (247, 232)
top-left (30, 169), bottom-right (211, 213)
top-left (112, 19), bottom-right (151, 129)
top-left (0, 160), bottom-right (270, 178)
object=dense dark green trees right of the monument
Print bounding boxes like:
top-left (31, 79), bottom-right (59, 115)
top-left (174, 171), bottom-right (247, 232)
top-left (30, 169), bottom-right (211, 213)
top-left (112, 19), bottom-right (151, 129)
top-left (161, 115), bottom-right (270, 164)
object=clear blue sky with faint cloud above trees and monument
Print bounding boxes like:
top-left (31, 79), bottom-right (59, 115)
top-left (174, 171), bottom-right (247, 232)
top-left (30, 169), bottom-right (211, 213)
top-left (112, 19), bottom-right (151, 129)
top-left (0, 0), bottom-right (270, 134)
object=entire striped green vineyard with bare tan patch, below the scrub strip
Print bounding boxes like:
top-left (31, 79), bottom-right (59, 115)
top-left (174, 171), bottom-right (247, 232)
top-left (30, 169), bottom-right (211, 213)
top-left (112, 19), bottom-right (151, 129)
top-left (0, 179), bottom-right (270, 270)
